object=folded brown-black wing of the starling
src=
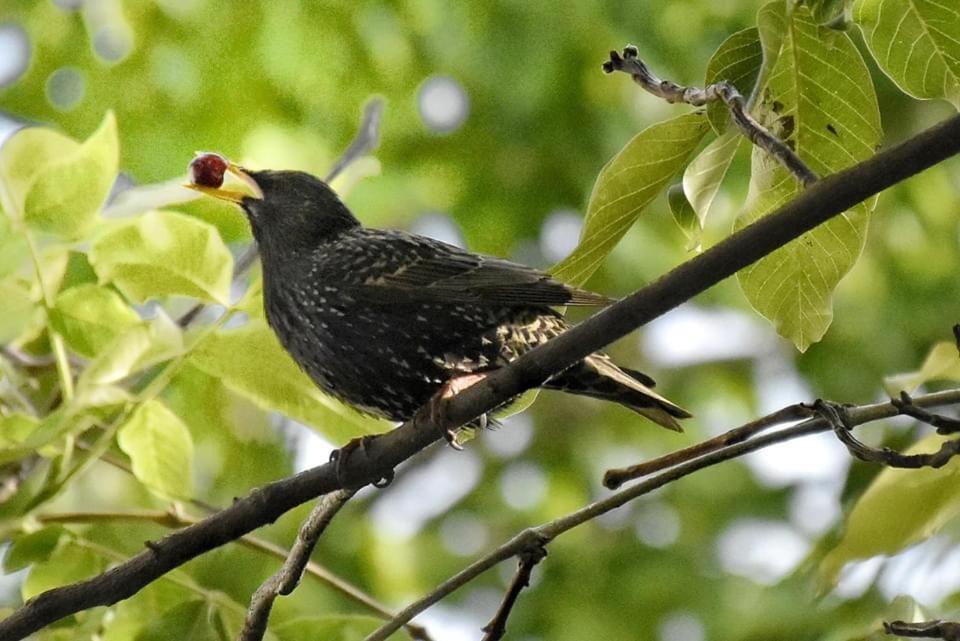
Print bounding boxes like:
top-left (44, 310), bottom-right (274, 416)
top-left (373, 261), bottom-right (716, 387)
top-left (348, 236), bottom-right (613, 305)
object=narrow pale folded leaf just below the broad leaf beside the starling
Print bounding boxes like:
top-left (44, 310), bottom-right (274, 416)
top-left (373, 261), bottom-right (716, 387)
top-left (77, 310), bottom-right (183, 388)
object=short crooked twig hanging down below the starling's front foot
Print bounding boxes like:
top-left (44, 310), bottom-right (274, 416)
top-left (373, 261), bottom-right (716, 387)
top-left (239, 490), bottom-right (356, 641)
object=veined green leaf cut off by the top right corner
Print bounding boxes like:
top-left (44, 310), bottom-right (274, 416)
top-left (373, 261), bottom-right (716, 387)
top-left (853, 0), bottom-right (960, 108)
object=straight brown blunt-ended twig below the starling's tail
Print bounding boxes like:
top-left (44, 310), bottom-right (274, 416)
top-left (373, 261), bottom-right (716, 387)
top-left (603, 403), bottom-right (813, 490)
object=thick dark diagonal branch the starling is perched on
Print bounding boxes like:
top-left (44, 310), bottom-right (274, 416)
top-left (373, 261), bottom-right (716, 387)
top-left (0, 116), bottom-right (960, 641)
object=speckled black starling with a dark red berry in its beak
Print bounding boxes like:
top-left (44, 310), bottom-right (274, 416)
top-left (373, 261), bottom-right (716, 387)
top-left (190, 154), bottom-right (690, 430)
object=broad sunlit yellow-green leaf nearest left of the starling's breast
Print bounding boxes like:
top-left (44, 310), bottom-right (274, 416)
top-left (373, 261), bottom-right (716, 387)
top-left (90, 211), bottom-right (233, 305)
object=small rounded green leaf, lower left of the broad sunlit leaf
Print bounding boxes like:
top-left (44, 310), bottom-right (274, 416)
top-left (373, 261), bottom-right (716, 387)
top-left (50, 285), bottom-right (140, 358)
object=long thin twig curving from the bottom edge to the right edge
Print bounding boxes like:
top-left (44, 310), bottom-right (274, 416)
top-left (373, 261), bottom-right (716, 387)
top-left (364, 389), bottom-right (960, 641)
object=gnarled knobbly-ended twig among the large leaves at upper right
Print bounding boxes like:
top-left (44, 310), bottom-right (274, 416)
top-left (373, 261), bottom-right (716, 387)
top-left (603, 45), bottom-right (817, 187)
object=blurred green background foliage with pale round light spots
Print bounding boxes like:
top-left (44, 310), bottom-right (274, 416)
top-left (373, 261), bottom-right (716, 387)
top-left (0, 0), bottom-right (960, 641)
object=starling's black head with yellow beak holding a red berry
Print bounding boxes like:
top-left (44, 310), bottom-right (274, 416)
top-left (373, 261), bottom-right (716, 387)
top-left (186, 153), bottom-right (360, 254)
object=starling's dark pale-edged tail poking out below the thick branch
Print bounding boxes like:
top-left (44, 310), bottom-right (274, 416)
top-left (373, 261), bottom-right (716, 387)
top-left (544, 354), bottom-right (691, 432)
